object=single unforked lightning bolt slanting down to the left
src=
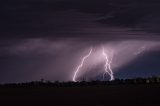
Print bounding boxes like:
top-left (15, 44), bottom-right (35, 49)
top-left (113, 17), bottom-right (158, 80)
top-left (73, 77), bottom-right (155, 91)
top-left (72, 48), bottom-right (92, 82)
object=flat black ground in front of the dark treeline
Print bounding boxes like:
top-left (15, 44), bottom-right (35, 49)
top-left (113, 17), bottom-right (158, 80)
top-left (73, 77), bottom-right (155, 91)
top-left (0, 84), bottom-right (160, 106)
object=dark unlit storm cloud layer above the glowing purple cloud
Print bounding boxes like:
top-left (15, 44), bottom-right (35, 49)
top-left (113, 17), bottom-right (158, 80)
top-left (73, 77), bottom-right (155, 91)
top-left (0, 0), bottom-right (160, 39)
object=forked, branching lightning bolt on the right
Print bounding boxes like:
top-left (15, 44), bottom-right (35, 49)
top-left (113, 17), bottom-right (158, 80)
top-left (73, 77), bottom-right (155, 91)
top-left (102, 47), bottom-right (114, 81)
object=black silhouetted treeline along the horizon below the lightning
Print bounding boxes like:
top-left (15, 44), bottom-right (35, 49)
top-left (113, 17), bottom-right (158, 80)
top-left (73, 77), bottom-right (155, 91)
top-left (0, 77), bottom-right (160, 87)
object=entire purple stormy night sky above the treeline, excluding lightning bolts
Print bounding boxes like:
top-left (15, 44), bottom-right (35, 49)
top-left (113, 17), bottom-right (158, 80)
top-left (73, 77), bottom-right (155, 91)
top-left (0, 0), bottom-right (160, 83)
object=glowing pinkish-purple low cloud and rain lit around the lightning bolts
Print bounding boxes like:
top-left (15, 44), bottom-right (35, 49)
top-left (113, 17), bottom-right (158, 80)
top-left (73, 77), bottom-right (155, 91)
top-left (0, 38), bottom-right (160, 81)
